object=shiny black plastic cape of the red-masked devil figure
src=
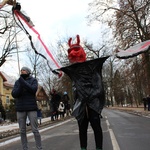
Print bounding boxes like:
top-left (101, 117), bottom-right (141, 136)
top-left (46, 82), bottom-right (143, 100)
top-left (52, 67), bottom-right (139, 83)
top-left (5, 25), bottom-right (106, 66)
top-left (60, 57), bottom-right (108, 120)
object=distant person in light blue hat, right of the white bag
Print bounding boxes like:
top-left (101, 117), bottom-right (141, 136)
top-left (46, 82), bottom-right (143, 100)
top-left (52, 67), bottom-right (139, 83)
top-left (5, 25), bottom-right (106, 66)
top-left (62, 91), bottom-right (70, 116)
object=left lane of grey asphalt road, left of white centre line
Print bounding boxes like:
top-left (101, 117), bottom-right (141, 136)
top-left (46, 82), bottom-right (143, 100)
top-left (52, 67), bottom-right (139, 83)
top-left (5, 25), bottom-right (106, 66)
top-left (0, 114), bottom-right (113, 150)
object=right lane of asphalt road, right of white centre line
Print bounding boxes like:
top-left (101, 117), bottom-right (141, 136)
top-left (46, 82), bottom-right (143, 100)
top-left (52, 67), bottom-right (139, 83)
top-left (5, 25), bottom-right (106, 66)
top-left (103, 109), bottom-right (150, 150)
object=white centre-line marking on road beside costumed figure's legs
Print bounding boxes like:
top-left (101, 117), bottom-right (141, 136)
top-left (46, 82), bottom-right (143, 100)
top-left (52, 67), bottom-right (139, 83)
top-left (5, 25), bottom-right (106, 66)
top-left (106, 120), bottom-right (120, 150)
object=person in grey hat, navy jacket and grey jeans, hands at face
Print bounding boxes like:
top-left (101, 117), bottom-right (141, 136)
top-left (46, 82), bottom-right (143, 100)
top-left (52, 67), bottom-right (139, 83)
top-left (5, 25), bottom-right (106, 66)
top-left (12, 67), bottom-right (42, 150)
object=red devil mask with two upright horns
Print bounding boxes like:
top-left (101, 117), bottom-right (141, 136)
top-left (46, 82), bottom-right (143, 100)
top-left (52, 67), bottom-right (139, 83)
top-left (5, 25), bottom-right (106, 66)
top-left (68, 35), bottom-right (86, 63)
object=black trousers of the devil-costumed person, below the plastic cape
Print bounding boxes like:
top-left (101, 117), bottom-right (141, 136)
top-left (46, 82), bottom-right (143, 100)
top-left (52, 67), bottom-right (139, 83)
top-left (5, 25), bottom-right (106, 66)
top-left (78, 108), bottom-right (103, 149)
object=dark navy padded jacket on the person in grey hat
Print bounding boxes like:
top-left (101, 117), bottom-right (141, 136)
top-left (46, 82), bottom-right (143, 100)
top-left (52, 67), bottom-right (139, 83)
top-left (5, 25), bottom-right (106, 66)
top-left (11, 76), bottom-right (38, 111)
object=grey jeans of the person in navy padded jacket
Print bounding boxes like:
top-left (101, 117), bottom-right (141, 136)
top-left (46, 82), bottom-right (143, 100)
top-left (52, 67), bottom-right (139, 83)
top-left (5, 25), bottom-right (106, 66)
top-left (17, 111), bottom-right (42, 150)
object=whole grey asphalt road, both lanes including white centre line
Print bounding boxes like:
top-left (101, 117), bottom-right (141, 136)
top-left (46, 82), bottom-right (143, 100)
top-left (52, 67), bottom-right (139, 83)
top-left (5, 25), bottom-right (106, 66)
top-left (0, 109), bottom-right (150, 150)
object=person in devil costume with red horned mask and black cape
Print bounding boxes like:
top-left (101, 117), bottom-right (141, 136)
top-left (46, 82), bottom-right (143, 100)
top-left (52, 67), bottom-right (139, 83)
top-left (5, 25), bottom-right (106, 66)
top-left (59, 35), bottom-right (109, 150)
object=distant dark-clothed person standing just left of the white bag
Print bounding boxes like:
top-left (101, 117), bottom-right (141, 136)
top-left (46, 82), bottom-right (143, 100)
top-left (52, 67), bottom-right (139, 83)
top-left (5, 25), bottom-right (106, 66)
top-left (50, 89), bottom-right (61, 121)
